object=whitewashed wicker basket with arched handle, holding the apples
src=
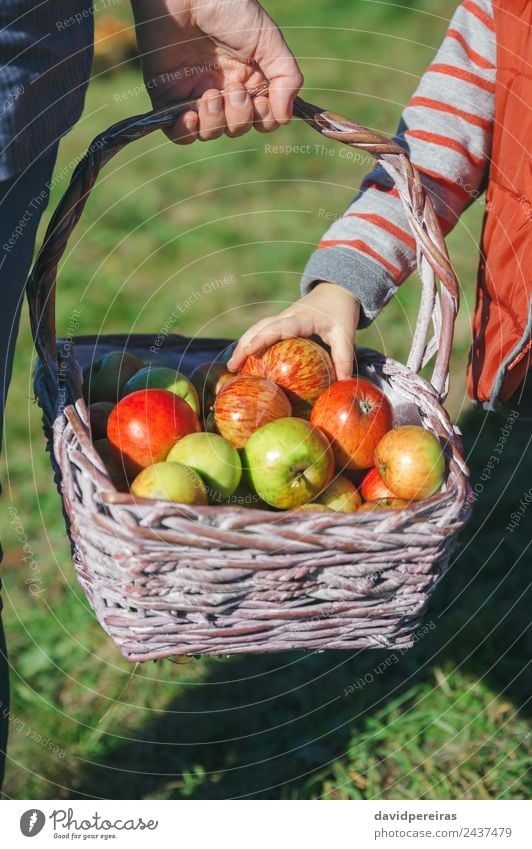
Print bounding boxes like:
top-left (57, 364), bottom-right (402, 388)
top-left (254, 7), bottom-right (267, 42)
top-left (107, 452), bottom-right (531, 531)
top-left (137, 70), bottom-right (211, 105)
top-left (28, 89), bottom-right (470, 661)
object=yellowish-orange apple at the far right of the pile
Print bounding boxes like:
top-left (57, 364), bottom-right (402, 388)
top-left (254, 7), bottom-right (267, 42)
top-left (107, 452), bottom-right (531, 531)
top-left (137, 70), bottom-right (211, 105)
top-left (375, 425), bottom-right (445, 501)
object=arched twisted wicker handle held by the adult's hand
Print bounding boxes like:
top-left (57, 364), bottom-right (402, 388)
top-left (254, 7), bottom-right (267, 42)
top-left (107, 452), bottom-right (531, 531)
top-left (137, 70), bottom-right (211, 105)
top-left (27, 84), bottom-right (459, 400)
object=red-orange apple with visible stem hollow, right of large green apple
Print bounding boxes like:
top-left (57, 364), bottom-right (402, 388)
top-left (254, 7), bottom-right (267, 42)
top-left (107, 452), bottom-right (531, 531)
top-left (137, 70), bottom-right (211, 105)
top-left (310, 377), bottom-right (393, 470)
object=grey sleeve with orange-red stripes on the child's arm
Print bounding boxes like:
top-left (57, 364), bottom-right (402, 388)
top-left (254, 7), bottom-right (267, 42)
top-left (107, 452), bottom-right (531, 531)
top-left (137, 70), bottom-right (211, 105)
top-left (301, 0), bottom-right (496, 327)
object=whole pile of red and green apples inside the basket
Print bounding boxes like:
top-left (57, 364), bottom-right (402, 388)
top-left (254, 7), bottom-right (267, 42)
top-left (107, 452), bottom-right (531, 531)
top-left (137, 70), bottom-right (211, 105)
top-left (83, 338), bottom-right (445, 513)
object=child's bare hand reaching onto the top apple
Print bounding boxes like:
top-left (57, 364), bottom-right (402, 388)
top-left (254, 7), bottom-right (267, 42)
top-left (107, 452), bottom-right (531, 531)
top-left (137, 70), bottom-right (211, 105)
top-left (227, 283), bottom-right (360, 380)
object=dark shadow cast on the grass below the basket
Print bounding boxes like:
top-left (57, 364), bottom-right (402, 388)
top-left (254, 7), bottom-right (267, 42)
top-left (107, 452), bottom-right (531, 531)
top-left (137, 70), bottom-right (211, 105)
top-left (68, 400), bottom-right (532, 799)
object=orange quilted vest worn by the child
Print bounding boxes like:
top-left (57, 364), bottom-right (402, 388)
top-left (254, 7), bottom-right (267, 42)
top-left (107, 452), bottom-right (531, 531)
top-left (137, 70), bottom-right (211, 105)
top-left (468, 0), bottom-right (532, 407)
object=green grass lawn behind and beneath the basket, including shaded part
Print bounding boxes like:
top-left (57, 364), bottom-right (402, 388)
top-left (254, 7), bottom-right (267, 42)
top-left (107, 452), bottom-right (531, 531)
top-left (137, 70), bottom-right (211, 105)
top-left (0, 0), bottom-right (531, 799)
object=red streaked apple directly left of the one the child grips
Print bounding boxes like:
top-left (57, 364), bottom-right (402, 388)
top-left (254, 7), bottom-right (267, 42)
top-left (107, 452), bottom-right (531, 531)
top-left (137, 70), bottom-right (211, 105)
top-left (214, 376), bottom-right (292, 448)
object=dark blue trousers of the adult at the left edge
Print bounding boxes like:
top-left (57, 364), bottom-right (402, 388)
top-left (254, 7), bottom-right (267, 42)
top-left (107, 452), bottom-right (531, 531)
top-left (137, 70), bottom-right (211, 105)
top-left (0, 146), bottom-right (57, 787)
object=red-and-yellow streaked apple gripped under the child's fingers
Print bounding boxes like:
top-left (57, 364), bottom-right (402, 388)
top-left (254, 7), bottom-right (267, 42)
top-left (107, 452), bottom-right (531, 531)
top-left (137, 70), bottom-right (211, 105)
top-left (240, 336), bottom-right (336, 418)
